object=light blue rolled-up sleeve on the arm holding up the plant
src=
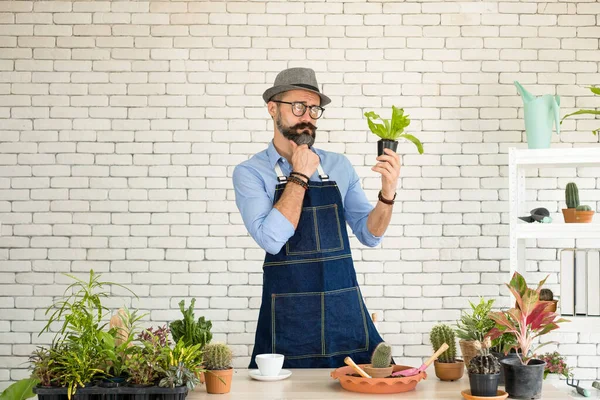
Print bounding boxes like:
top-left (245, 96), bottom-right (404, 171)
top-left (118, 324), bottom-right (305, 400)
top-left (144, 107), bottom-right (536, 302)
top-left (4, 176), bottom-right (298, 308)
top-left (344, 159), bottom-right (383, 247)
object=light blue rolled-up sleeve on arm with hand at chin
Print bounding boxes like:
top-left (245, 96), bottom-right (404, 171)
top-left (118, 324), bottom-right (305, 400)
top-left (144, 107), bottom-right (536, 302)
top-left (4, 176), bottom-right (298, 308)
top-left (233, 165), bottom-right (294, 254)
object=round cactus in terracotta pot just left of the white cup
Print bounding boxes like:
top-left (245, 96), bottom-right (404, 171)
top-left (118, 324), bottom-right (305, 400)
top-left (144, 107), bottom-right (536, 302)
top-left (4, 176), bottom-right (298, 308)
top-left (204, 343), bottom-right (233, 394)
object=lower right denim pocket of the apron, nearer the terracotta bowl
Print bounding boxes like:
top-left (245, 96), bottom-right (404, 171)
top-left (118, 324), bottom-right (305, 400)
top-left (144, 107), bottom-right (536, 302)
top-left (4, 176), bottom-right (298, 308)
top-left (325, 287), bottom-right (369, 355)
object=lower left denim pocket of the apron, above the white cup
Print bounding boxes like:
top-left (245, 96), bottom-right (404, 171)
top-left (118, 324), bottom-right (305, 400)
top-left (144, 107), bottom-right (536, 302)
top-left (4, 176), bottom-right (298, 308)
top-left (271, 292), bottom-right (324, 358)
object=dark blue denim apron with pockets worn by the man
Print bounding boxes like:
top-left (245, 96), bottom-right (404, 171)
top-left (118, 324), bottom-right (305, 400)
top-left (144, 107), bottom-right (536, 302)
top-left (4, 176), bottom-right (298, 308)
top-left (249, 164), bottom-right (383, 368)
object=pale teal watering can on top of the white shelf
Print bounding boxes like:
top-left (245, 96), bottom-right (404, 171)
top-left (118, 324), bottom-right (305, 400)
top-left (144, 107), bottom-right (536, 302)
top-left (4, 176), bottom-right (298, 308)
top-left (515, 81), bottom-right (560, 149)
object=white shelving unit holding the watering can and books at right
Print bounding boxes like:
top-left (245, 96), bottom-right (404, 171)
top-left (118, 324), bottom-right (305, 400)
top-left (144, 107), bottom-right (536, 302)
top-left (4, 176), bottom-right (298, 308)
top-left (508, 147), bottom-right (600, 324)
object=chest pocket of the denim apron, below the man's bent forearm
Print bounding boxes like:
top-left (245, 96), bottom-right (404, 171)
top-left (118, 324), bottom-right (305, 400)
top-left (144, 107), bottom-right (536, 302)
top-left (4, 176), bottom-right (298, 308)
top-left (285, 204), bottom-right (344, 256)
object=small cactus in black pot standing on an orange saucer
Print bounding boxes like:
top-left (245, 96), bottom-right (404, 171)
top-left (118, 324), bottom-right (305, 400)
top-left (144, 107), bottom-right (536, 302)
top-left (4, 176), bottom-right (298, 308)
top-left (467, 337), bottom-right (500, 397)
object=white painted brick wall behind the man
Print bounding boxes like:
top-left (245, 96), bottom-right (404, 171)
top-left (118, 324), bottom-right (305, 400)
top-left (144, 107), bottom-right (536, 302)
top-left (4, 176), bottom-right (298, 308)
top-left (0, 0), bottom-right (600, 389)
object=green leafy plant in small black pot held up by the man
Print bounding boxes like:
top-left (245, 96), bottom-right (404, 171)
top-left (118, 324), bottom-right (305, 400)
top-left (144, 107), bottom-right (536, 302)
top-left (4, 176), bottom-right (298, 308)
top-left (364, 106), bottom-right (423, 156)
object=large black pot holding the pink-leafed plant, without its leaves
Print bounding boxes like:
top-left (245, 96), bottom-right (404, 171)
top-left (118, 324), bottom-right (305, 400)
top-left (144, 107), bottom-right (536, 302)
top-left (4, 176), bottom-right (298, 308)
top-left (500, 357), bottom-right (546, 399)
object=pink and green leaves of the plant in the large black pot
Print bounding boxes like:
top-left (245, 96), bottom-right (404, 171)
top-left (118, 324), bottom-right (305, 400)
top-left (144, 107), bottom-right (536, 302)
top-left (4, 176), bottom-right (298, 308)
top-left (486, 272), bottom-right (569, 365)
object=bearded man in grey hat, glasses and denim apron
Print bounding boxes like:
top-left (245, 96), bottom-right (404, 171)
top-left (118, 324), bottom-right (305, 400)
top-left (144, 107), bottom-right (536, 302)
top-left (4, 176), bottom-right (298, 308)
top-left (233, 68), bottom-right (400, 368)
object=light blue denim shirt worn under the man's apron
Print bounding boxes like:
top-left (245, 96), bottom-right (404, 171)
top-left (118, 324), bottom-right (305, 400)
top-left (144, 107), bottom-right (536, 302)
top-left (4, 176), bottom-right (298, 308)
top-left (233, 141), bottom-right (382, 254)
